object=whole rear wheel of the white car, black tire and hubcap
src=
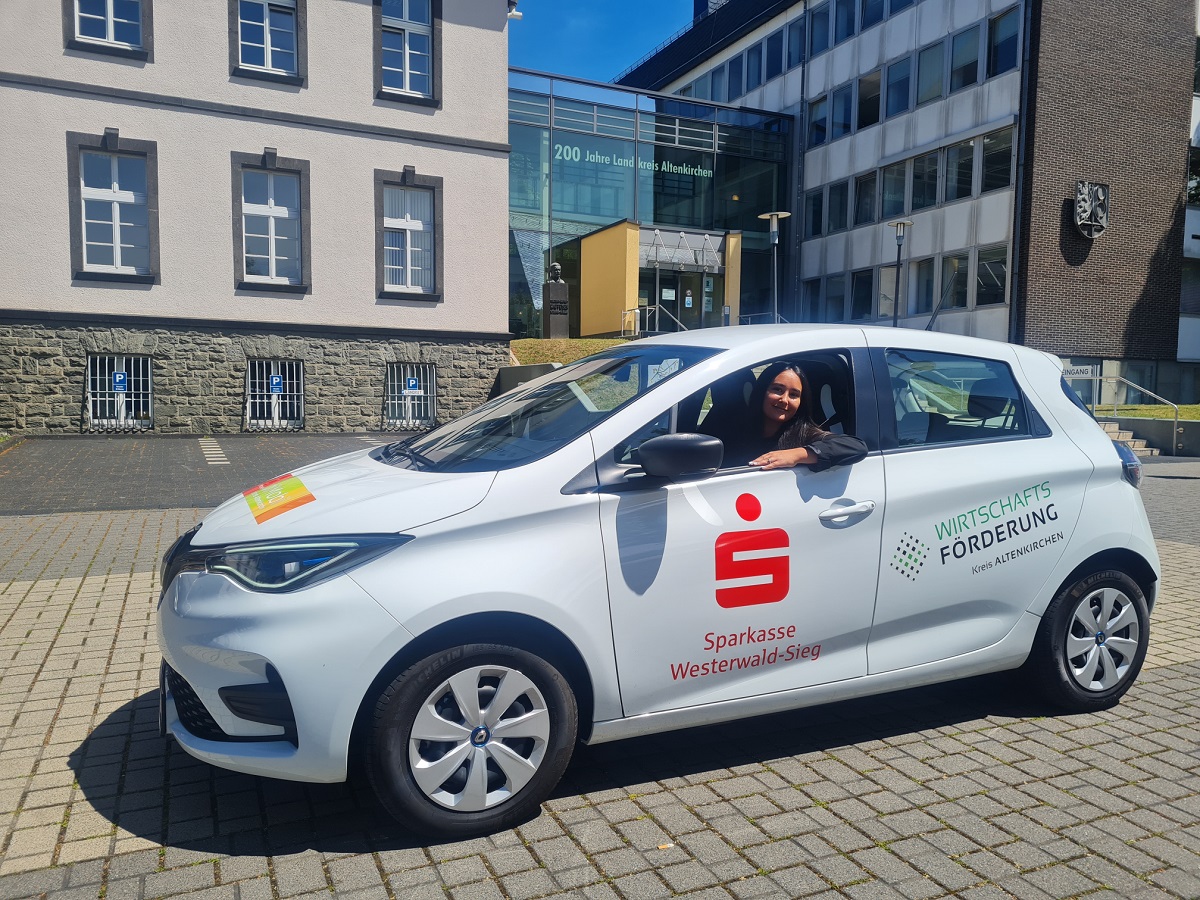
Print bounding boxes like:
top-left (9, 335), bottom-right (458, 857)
top-left (1025, 570), bottom-right (1150, 713)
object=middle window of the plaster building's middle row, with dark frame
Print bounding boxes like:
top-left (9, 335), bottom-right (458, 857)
top-left (230, 148), bottom-right (312, 293)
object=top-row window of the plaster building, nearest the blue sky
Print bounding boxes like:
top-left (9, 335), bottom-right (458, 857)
top-left (373, 0), bottom-right (439, 104)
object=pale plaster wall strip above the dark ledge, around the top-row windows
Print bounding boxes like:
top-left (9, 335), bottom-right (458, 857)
top-left (0, 0), bottom-right (508, 143)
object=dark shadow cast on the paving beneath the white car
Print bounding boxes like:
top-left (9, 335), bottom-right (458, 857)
top-left (68, 673), bottom-right (1070, 856)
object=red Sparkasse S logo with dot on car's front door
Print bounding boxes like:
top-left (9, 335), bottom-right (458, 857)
top-left (714, 493), bottom-right (791, 608)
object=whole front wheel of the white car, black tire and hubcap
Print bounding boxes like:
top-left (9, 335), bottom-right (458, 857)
top-left (366, 643), bottom-right (578, 839)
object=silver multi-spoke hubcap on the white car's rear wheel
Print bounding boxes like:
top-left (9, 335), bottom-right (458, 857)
top-left (1066, 588), bottom-right (1141, 691)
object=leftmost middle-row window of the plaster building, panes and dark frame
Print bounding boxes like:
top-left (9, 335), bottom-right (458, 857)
top-left (67, 128), bottom-right (158, 283)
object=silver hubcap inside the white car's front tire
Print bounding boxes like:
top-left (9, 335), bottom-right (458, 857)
top-left (408, 666), bottom-right (550, 812)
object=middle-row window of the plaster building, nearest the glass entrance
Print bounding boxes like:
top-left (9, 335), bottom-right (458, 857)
top-left (374, 169), bottom-right (443, 300)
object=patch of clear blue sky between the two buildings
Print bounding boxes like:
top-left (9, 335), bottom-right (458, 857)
top-left (509, 0), bottom-right (692, 82)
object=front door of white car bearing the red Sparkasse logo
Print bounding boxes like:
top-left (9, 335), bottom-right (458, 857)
top-left (594, 350), bottom-right (883, 715)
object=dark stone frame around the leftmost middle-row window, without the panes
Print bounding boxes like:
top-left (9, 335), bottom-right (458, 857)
top-left (67, 128), bottom-right (162, 284)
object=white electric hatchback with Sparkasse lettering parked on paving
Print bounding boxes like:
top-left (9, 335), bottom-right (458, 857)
top-left (158, 325), bottom-right (1159, 836)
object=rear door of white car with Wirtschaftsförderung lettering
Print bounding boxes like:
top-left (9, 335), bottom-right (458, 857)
top-left (868, 336), bottom-right (1092, 674)
